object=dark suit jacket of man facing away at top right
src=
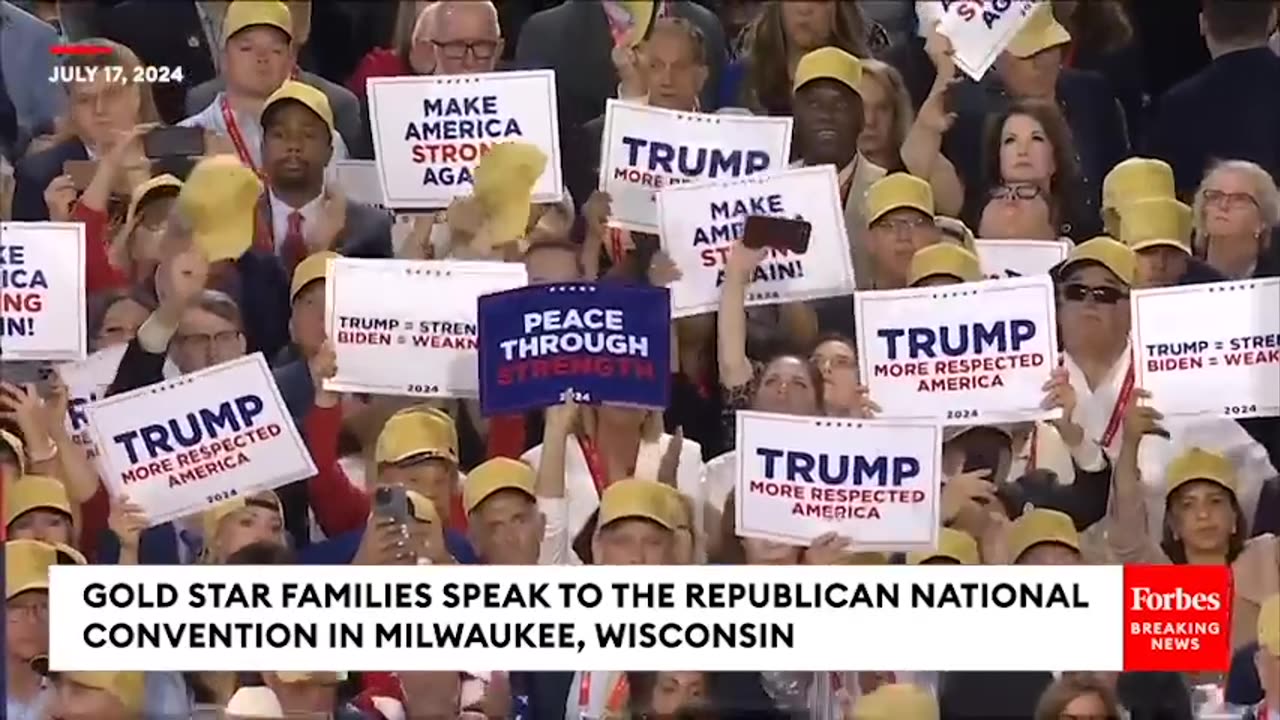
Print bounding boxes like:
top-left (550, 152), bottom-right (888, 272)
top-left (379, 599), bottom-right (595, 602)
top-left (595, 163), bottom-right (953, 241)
top-left (1147, 47), bottom-right (1280, 193)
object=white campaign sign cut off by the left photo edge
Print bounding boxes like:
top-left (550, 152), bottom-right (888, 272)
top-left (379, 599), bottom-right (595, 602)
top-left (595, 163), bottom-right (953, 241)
top-left (0, 223), bottom-right (88, 360)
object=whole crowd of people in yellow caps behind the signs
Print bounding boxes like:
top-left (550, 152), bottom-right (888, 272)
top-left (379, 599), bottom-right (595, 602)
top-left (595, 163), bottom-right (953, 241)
top-left (0, 0), bottom-right (1280, 720)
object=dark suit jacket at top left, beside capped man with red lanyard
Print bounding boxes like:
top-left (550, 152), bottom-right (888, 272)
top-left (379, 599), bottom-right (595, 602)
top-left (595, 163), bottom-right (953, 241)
top-left (99, 0), bottom-right (218, 123)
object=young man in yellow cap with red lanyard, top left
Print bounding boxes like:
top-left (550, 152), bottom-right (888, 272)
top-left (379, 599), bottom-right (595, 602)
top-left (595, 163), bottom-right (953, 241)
top-left (179, 0), bottom-right (347, 173)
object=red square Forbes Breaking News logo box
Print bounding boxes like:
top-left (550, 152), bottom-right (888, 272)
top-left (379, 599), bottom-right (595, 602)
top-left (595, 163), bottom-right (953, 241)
top-left (1124, 565), bottom-right (1235, 673)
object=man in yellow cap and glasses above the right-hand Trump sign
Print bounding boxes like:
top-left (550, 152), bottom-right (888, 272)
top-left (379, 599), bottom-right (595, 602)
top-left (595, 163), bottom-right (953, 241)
top-left (860, 173), bottom-right (942, 290)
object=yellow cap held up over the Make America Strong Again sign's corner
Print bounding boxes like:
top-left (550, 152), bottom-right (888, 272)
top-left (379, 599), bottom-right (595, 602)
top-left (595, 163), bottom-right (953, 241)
top-left (472, 142), bottom-right (547, 245)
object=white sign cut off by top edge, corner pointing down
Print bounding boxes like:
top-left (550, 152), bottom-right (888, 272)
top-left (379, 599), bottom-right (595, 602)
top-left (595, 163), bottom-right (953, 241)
top-left (938, 0), bottom-right (1050, 81)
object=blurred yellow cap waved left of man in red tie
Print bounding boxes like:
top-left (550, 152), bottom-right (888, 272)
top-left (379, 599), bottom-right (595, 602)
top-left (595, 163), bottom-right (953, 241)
top-left (178, 155), bottom-right (262, 263)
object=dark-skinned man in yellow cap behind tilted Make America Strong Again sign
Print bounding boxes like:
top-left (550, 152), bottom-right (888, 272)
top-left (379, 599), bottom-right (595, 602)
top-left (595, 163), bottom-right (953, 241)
top-left (791, 46), bottom-right (884, 287)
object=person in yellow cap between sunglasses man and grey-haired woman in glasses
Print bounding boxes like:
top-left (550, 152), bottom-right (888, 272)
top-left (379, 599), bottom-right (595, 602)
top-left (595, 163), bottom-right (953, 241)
top-left (1119, 196), bottom-right (1226, 287)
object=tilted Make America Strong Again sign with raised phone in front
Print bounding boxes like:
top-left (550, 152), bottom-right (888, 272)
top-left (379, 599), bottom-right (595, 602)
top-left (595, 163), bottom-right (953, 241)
top-left (658, 165), bottom-right (858, 318)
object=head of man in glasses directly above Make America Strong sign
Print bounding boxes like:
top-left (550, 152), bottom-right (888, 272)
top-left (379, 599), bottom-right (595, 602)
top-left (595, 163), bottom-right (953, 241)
top-left (431, 0), bottom-right (503, 76)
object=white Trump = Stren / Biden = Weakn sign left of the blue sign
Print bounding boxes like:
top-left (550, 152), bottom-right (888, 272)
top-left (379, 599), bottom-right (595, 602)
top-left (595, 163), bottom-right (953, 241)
top-left (325, 258), bottom-right (529, 397)
